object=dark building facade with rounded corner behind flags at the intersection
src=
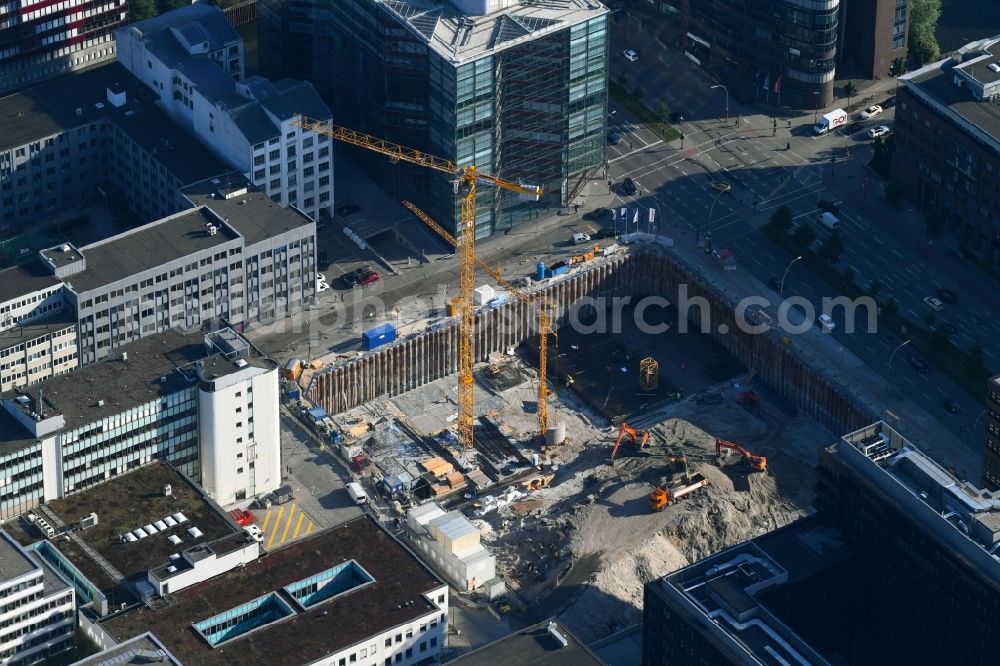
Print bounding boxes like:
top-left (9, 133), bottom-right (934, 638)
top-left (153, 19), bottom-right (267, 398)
top-left (636, 0), bottom-right (843, 109)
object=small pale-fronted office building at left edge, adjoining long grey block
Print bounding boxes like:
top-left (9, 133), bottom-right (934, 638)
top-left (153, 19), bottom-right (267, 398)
top-left (0, 261), bottom-right (79, 393)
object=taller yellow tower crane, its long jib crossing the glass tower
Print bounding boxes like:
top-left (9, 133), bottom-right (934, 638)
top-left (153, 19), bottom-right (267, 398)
top-left (293, 116), bottom-right (542, 448)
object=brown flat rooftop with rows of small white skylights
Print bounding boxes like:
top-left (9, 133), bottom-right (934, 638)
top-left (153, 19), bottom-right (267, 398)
top-left (46, 461), bottom-right (236, 591)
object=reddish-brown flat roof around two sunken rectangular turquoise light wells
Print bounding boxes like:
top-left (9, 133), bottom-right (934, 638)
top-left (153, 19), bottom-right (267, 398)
top-left (101, 516), bottom-right (443, 666)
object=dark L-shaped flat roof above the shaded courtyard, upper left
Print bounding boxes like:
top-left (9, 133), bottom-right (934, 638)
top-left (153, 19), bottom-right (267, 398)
top-left (0, 62), bottom-right (229, 183)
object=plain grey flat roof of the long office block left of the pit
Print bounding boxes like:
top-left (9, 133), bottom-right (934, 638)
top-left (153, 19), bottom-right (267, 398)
top-left (64, 207), bottom-right (239, 293)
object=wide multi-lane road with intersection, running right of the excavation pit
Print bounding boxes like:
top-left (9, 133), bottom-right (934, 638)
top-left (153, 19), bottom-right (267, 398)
top-left (596, 28), bottom-right (1000, 448)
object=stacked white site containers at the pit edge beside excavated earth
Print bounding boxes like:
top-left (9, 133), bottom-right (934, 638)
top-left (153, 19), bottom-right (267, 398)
top-left (406, 502), bottom-right (496, 596)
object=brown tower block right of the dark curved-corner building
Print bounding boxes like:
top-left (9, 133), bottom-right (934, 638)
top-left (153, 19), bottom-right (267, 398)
top-left (837, 0), bottom-right (910, 79)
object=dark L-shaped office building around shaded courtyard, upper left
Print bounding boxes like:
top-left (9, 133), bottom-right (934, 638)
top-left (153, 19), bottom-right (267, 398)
top-left (0, 63), bottom-right (229, 229)
